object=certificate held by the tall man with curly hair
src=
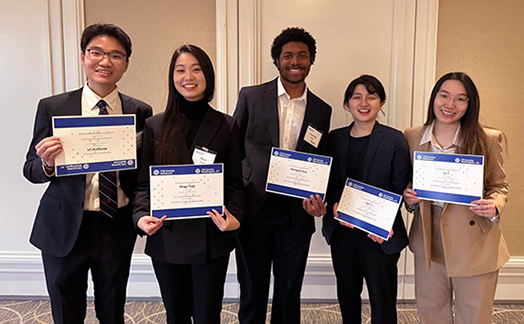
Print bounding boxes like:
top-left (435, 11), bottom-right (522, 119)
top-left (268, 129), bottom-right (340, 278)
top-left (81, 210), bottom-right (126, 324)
top-left (266, 147), bottom-right (331, 200)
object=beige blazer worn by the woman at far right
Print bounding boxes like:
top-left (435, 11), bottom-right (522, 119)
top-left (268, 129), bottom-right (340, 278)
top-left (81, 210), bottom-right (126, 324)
top-left (404, 126), bottom-right (509, 277)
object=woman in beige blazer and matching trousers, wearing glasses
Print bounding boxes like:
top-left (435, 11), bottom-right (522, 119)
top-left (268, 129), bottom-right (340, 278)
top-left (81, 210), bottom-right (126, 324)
top-left (404, 72), bottom-right (509, 324)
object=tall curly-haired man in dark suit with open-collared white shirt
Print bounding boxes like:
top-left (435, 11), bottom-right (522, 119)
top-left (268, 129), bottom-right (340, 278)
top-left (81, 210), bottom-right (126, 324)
top-left (233, 27), bottom-right (331, 324)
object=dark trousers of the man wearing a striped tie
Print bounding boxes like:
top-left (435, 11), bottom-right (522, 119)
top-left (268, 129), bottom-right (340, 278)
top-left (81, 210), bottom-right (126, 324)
top-left (42, 210), bottom-right (136, 324)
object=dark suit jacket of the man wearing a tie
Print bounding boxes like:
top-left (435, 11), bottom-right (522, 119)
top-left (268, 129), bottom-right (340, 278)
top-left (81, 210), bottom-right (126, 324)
top-left (24, 89), bottom-right (152, 257)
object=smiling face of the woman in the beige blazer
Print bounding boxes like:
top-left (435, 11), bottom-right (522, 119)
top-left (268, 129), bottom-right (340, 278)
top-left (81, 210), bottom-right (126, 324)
top-left (433, 80), bottom-right (468, 124)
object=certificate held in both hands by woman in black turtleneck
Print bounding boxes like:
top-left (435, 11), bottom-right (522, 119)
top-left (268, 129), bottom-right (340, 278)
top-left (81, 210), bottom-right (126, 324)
top-left (149, 163), bottom-right (224, 220)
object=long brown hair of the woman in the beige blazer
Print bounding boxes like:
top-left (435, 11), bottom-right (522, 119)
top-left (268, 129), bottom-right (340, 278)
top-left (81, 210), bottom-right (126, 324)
top-left (424, 72), bottom-right (488, 155)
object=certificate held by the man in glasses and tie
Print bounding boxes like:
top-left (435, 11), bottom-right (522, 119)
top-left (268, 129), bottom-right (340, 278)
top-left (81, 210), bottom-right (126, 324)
top-left (53, 115), bottom-right (136, 176)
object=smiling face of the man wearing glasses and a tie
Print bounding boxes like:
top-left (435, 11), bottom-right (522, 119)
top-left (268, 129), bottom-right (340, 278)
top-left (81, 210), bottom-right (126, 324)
top-left (80, 35), bottom-right (129, 97)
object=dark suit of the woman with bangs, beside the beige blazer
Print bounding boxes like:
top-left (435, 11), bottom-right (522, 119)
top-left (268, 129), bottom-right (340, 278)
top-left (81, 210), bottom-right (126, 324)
top-left (322, 122), bottom-right (411, 323)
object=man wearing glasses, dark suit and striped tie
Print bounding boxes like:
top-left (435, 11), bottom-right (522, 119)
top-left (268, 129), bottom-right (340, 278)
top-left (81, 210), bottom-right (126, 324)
top-left (24, 24), bottom-right (152, 324)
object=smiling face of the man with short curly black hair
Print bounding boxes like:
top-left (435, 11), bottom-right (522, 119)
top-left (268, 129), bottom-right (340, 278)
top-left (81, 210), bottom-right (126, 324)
top-left (277, 42), bottom-right (311, 84)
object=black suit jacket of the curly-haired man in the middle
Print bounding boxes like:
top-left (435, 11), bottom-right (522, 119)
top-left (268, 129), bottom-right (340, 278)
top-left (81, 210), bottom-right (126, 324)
top-left (233, 79), bottom-right (331, 234)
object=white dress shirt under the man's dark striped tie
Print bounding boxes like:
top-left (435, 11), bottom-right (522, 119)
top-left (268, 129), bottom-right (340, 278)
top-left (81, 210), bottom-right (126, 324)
top-left (82, 83), bottom-right (129, 211)
